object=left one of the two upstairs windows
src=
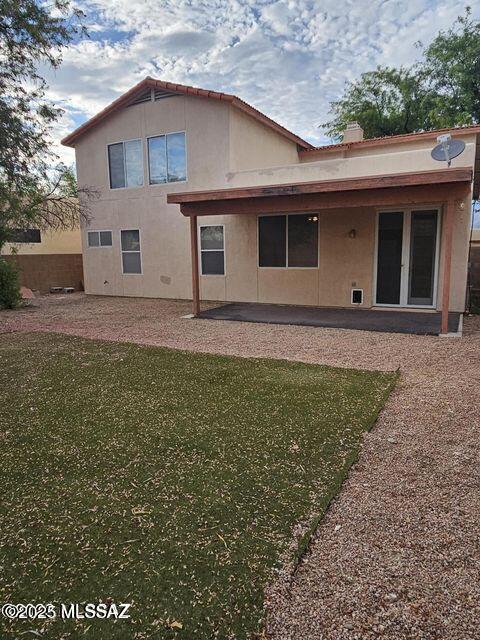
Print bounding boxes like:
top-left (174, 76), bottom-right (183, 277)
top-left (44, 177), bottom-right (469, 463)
top-left (108, 140), bottom-right (143, 189)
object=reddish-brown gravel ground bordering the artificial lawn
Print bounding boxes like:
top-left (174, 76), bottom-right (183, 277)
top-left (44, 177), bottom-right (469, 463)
top-left (0, 294), bottom-right (480, 640)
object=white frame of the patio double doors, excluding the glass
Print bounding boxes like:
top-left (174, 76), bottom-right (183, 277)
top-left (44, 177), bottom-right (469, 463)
top-left (372, 203), bottom-right (443, 309)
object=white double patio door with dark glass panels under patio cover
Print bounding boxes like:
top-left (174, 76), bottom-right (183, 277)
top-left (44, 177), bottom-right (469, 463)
top-left (375, 207), bottom-right (440, 308)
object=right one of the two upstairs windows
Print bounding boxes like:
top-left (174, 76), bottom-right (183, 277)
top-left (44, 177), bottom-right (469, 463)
top-left (148, 131), bottom-right (187, 184)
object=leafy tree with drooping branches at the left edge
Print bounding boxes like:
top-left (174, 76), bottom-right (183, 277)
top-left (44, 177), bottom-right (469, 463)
top-left (0, 0), bottom-right (95, 252)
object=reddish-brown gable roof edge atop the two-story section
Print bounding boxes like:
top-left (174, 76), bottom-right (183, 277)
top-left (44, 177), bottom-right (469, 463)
top-left (62, 76), bottom-right (314, 149)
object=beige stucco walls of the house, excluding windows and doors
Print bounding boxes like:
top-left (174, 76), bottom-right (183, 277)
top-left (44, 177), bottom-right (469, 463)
top-left (76, 96), bottom-right (476, 311)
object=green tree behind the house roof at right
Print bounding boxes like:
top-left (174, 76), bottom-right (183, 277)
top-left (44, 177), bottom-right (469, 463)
top-left (323, 8), bottom-right (480, 140)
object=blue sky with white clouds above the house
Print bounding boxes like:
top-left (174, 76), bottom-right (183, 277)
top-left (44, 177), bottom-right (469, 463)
top-left (48, 0), bottom-right (480, 163)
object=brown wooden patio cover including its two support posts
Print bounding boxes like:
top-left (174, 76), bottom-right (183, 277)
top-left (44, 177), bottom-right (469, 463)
top-left (167, 167), bottom-right (473, 334)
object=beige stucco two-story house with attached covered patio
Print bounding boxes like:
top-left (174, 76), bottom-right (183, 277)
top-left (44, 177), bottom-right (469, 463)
top-left (63, 78), bottom-right (480, 333)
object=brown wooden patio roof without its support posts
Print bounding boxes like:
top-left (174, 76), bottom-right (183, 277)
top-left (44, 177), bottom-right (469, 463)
top-left (167, 167), bottom-right (473, 216)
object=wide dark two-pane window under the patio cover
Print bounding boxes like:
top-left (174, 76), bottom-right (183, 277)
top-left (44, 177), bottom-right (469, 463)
top-left (258, 214), bottom-right (318, 268)
